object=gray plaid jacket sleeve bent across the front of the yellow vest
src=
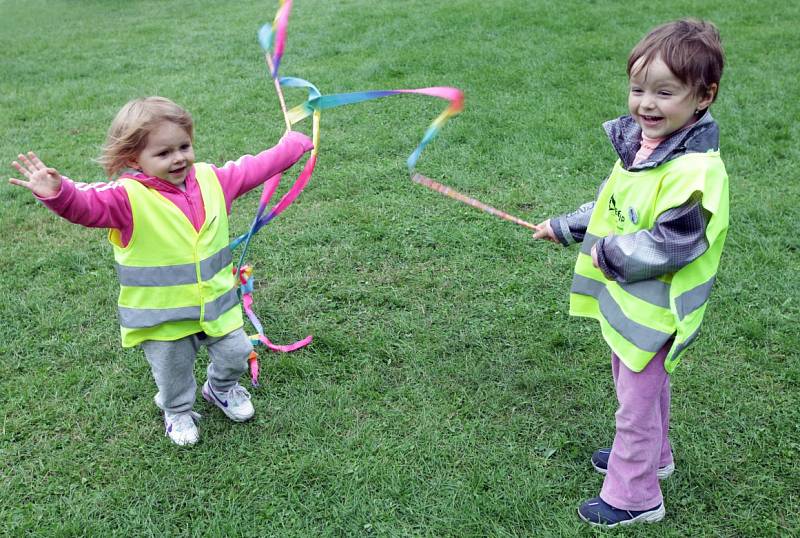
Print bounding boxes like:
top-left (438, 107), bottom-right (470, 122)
top-left (596, 196), bottom-right (711, 282)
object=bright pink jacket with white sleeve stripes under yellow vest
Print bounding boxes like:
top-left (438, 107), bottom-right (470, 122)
top-left (39, 131), bottom-right (313, 246)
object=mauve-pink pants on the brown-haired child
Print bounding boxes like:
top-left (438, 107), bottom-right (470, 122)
top-left (600, 341), bottom-right (672, 510)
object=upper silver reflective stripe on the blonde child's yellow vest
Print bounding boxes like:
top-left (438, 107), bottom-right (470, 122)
top-left (117, 247), bottom-right (232, 287)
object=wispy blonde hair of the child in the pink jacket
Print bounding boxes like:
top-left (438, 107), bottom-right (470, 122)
top-left (97, 96), bottom-right (194, 177)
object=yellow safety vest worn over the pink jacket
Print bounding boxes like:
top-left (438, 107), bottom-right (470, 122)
top-left (108, 163), bottom-right (243, 347)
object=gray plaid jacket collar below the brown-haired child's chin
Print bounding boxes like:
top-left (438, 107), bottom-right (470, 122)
top-left (603, 110), bottom-right (719, 171)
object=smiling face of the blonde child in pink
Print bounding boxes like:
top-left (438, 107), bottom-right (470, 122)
top-left (131, 121), bottom-right (194, 186)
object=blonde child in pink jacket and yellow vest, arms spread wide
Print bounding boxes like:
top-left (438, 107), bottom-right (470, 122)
top-left (9, 97), bottom-right (312, 445)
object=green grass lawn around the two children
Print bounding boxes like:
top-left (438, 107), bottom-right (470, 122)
top-left (0, 0), bottom-right (800, 537)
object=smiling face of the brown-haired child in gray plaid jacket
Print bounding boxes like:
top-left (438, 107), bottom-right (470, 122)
top-left (628, 57), bottom-right (716, 138)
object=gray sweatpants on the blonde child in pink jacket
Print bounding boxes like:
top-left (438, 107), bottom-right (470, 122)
top-left (140, 328), bottom-right (253, 413)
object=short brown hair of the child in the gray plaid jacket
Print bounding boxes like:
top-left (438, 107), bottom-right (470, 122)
top-left (628, 19), bottom-right (725, 102)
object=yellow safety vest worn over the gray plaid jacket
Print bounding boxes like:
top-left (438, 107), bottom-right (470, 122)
top-left (570, 151), bottom-right (728, 373)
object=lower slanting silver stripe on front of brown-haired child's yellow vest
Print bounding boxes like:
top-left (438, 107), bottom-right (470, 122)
top-left (571, 275), bottom-right (672, 353)
